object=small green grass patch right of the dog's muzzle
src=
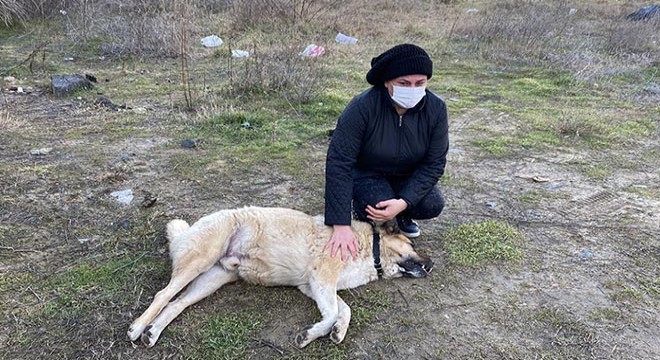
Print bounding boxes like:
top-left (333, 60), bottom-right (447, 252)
top-left (443, 220), bottom-right (524, 266)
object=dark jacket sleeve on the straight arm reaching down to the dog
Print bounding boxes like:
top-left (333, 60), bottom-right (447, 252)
top-left (325, 99), bottom-right (366, 225)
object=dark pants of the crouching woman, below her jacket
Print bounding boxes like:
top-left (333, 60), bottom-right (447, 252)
top-left (353, 176), bottom-right (445, 221)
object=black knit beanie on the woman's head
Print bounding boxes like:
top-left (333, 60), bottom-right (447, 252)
top-left (367, 44), bottom-right (433, 85)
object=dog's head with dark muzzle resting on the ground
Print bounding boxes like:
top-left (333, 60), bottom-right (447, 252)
top-left (379, 223), bottom-right (433, 278)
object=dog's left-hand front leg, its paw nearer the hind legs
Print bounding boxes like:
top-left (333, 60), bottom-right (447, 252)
top-left (296, 277), bottom-right (339, 348)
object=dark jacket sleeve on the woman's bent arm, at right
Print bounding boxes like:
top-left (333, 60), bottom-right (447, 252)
top-left (399, 102), bottom-right (449, 207)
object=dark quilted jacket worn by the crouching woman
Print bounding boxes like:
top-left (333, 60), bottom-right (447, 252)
top-left (325, 86), bottom-right (449, 225)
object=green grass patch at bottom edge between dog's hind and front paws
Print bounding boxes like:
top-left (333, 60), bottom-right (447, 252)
top-left (194, 311), bottom-right (263, 360)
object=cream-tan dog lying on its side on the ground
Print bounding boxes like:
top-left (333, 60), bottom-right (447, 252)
top-left (128, 207), bottom-right (433, 347)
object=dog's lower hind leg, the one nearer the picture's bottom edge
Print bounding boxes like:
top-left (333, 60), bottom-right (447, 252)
top-left (141, 265), bottom-right (238, 347)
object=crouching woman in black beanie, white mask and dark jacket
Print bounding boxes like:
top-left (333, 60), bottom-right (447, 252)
top-left (325, 44), bottom-right (449, 261)
